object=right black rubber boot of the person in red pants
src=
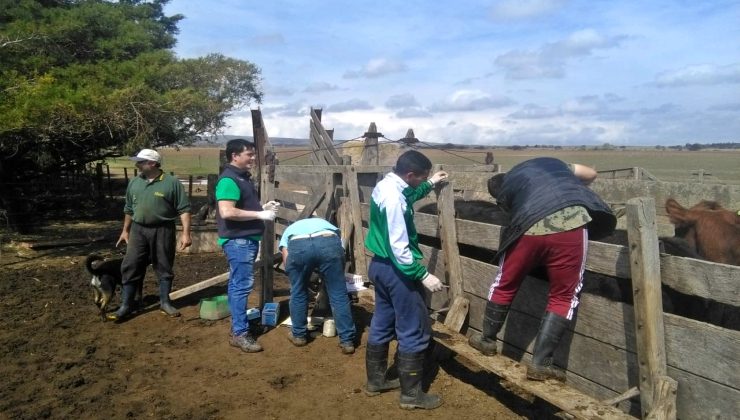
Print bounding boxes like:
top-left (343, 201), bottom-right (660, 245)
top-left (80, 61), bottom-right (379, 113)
top-left (527, 312), bottom-right (570, 381)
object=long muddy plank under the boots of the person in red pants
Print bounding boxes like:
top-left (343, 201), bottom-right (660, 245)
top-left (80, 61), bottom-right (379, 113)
top-left (433, 322), bottom-right (633, 419)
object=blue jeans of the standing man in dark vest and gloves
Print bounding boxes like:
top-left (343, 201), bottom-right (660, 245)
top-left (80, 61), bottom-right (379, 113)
top-left (223, 239), bottom-right (259, 336)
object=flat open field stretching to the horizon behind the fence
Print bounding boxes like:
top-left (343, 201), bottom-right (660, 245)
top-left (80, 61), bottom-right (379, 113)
top-left (107, 147), bottom-right (740, 184)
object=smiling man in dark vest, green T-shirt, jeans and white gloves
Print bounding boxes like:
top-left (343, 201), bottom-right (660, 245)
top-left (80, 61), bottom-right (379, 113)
top-left (216, 139), bottom-right (280, 353)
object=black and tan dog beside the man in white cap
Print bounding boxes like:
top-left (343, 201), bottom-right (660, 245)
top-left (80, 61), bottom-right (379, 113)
top-left (85, 254), bottom-right (144, 321)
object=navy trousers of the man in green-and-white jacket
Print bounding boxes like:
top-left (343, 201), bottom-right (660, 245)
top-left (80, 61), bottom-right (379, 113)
top-left (367, 257), bottom-right (432, 353)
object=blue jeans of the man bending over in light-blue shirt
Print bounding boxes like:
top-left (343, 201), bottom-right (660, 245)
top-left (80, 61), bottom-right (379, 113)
top-left (285, 236), bottom-right (356, 344)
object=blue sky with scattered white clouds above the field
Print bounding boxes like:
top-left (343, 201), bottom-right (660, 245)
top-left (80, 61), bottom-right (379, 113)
top-left (165, 0), bottom-right (740, 145)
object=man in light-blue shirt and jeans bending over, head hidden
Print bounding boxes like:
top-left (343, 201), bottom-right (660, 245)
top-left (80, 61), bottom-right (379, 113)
top-left (278, 217), bottom-right (356, 354)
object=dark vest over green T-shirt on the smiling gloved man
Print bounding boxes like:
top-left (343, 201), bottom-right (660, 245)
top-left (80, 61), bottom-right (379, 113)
top-left (216, 165), bottom-right (265, 239)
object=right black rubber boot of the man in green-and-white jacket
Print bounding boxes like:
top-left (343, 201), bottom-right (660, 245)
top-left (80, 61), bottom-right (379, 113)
top-left (398, 352), bottom-right (442, 410)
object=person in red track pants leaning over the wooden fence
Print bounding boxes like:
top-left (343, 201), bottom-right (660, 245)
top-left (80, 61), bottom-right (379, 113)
top-left (469, 157), bottom-right (617, 381)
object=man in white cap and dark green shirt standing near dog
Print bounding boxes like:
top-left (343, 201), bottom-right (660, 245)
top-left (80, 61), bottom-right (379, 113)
top-left (108, 149), bottom-right (192, 321)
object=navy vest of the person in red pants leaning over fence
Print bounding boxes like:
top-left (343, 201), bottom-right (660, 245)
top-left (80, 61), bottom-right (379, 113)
top-left (495, 157), bottom-right (617, 261)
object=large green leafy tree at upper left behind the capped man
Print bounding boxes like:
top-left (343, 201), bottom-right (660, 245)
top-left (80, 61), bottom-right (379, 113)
top-left (0, 0), bottom-right (263, 231)
